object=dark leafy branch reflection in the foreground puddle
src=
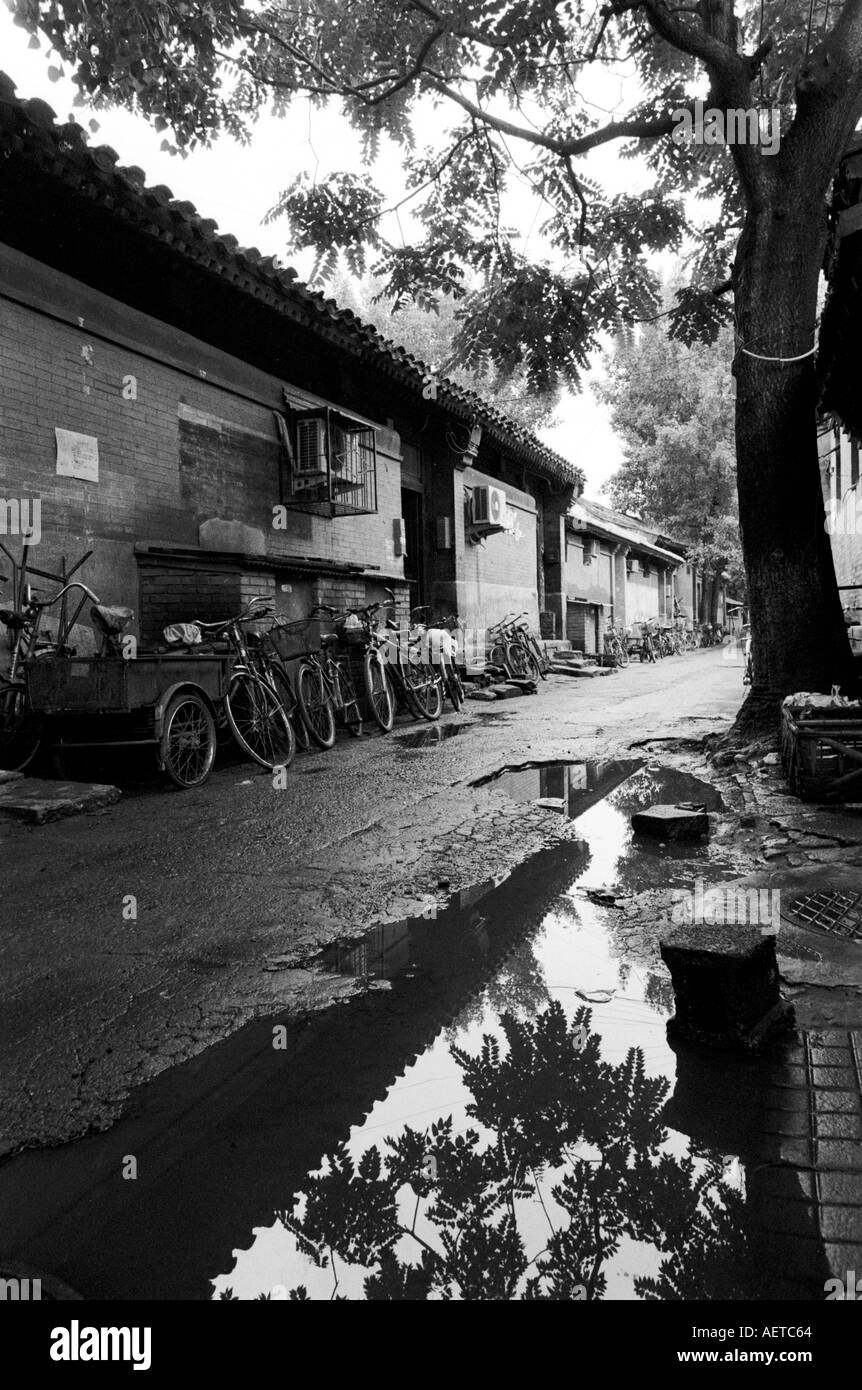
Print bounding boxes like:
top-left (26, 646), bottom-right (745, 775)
top-left (221, 1002), bottom-right (755, 1301)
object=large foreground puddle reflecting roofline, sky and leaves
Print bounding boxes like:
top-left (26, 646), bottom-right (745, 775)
top-left (0, 765), bottom-right (824, 1301)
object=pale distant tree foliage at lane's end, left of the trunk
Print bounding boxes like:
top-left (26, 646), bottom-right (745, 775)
top-left (594, 324), bottom-right (742, 584)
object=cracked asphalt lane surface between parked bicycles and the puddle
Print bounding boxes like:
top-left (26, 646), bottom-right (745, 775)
top-left (0, 649), bottom-right (862, 1155)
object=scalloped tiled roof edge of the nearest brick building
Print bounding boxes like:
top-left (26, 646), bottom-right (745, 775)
top-left (0, 72), bottom-right (583, 484)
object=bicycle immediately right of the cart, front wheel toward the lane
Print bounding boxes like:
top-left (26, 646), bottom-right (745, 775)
top-left (184, 595), bottom-right (296, 771)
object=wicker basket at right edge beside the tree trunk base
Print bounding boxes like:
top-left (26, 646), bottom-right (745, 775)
top-left (781, 706), bottom-right (862, 802)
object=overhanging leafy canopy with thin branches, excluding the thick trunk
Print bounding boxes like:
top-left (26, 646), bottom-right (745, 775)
top-left (13, 0), bottom-right (856, 392)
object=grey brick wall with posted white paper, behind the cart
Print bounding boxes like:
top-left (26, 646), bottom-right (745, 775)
top-left (0, 249), bottom-right (403, 639)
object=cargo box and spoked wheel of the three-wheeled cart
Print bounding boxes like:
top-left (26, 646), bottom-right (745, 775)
top-left (26, 652), bottom-right (232, 788)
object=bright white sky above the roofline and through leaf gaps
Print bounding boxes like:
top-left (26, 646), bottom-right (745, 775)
top-left (0, 7), bottom-right (628, 496)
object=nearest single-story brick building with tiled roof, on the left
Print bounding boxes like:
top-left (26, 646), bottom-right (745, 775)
top-left (0, 75), bottom-right (583, 658)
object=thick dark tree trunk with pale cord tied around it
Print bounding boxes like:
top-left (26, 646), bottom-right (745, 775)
top-left (734, 193), bottom-right (852, 733)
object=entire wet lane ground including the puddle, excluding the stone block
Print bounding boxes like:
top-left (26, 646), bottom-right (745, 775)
top-left (0, 653), bottom-right (862, 1300)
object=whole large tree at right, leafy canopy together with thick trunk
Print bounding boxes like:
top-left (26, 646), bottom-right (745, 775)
top-left (11, 0), bottom-right (862, 721)
